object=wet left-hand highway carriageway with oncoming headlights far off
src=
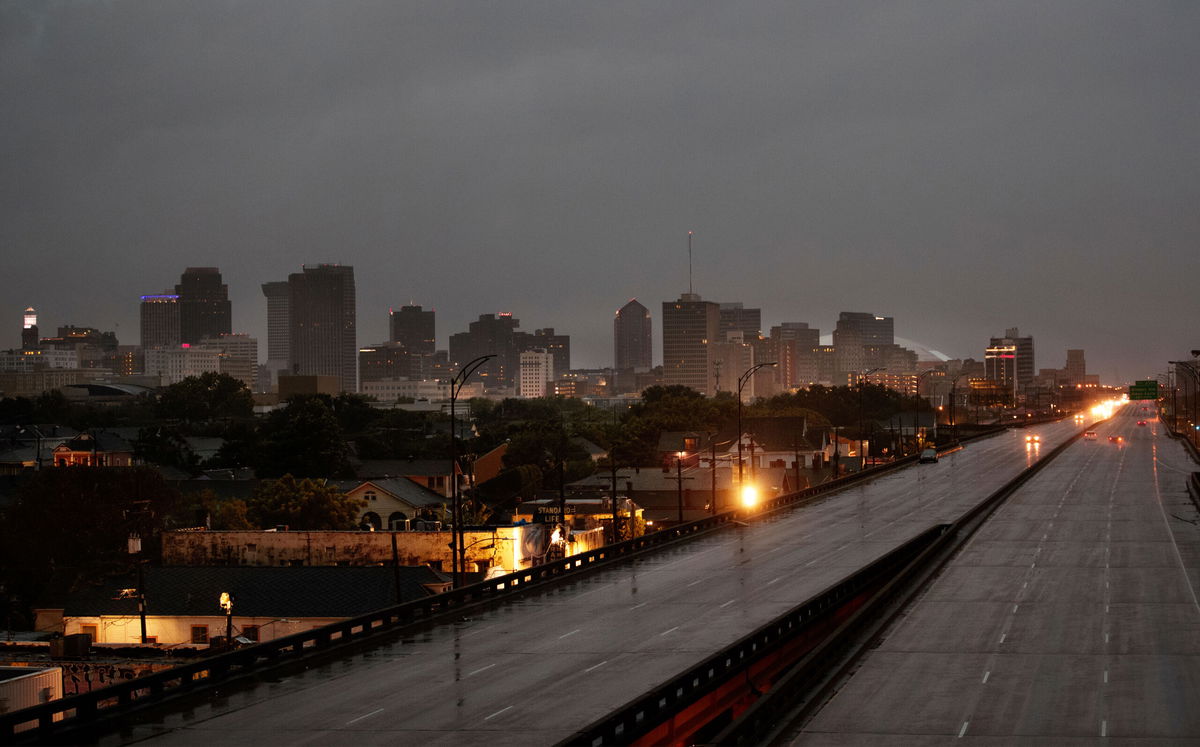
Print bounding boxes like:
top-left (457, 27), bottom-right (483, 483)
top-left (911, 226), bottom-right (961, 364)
top-left (114, 423), bottom-right (1078, 746)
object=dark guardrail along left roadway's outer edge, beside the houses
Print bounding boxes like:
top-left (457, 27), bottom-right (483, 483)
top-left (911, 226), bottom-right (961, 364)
top-left (0, 434), bottom-right (955, 743)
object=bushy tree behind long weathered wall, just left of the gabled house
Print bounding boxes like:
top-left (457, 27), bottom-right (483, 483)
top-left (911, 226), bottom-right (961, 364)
top-left (246, 474), bottom-right (366, 531)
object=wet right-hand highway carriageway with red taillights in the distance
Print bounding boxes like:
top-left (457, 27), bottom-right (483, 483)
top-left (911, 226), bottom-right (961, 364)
top-left (785, 404), bottom-right (1200, 746)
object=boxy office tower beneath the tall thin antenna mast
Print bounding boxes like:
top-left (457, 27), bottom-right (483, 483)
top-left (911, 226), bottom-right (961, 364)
top-left (662, 293), bottom-right (715, 394)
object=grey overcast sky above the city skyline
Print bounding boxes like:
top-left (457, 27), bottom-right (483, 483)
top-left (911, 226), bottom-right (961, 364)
top-left (0, 0), bottom-right (1200, 382)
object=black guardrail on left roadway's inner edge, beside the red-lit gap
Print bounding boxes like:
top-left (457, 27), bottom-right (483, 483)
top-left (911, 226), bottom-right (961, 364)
top-left (559, 525), bottom-right (949, 747)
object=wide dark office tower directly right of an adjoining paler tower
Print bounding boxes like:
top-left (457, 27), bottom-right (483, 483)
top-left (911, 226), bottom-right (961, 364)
top-left (288, 264), bottom-right (359, 392)
